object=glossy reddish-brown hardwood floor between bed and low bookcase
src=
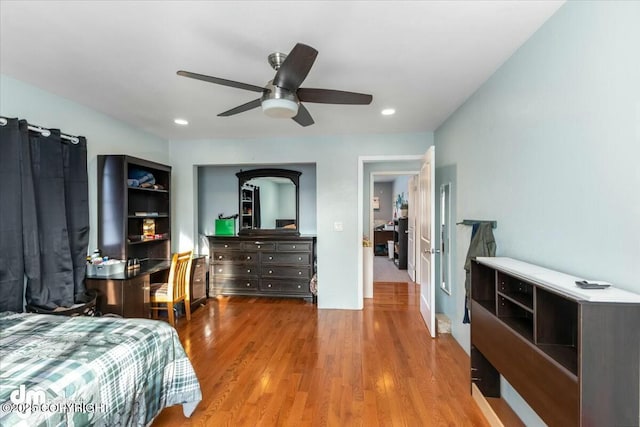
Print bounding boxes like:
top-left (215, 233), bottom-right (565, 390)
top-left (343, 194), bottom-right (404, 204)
top-left (153, 283), bottom-right (488, 427)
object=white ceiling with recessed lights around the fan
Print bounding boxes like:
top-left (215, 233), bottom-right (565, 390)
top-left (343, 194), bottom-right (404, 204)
top-left (0, 0), bottom-right (562, 140)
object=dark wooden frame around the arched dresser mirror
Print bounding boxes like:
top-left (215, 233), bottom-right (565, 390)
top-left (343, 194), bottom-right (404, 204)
top-left (236, 168), bottom-right (302, 236)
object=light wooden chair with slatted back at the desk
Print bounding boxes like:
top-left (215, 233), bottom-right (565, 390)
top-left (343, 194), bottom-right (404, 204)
top-left (150, 251), bottom-right (193, 327)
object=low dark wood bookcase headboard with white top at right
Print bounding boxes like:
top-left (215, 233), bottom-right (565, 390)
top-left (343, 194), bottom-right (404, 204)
top-left (471, 258), bottom-right (640, 427)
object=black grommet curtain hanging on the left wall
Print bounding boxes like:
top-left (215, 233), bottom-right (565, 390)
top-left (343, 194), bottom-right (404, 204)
top-left (0, 119), bottom-right (89, 312)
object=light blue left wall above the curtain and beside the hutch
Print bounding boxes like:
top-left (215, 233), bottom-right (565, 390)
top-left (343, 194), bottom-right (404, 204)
top-left (0, 74), bottom-right (169, 252)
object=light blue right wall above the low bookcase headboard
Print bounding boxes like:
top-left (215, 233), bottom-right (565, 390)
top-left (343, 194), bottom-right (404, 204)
top-left (435, 2), bottom-right (640, 425)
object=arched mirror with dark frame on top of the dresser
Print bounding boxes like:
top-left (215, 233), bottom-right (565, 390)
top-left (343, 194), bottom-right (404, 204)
top-left (236, 169), bottom-right (301, 235)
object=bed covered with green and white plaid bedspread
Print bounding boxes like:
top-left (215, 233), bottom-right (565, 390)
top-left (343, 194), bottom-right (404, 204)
top-left (0, 312), bottom-right (202, 426)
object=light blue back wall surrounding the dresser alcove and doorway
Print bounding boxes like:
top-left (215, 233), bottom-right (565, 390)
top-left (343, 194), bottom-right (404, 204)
top-left (169, 133), bottom-right (433, 309)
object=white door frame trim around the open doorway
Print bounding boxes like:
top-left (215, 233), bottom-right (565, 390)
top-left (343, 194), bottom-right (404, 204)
top-left (354, 154), bottom-right (424, 310)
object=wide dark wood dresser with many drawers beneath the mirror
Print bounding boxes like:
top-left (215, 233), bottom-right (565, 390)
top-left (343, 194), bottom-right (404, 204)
top-left (208, 235), bottom-right (316, 300)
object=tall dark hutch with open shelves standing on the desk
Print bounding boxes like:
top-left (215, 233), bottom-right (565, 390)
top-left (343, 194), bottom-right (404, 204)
top-left (98, 154), bottom-right (171, 260)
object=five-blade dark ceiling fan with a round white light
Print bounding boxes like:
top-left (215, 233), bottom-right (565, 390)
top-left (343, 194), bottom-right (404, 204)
top-left (178, 43), bottom-right (373, 126)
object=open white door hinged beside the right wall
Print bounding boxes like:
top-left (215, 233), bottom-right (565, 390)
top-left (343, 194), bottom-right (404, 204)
top-left (418, 147), bottom-right (436, 338)
